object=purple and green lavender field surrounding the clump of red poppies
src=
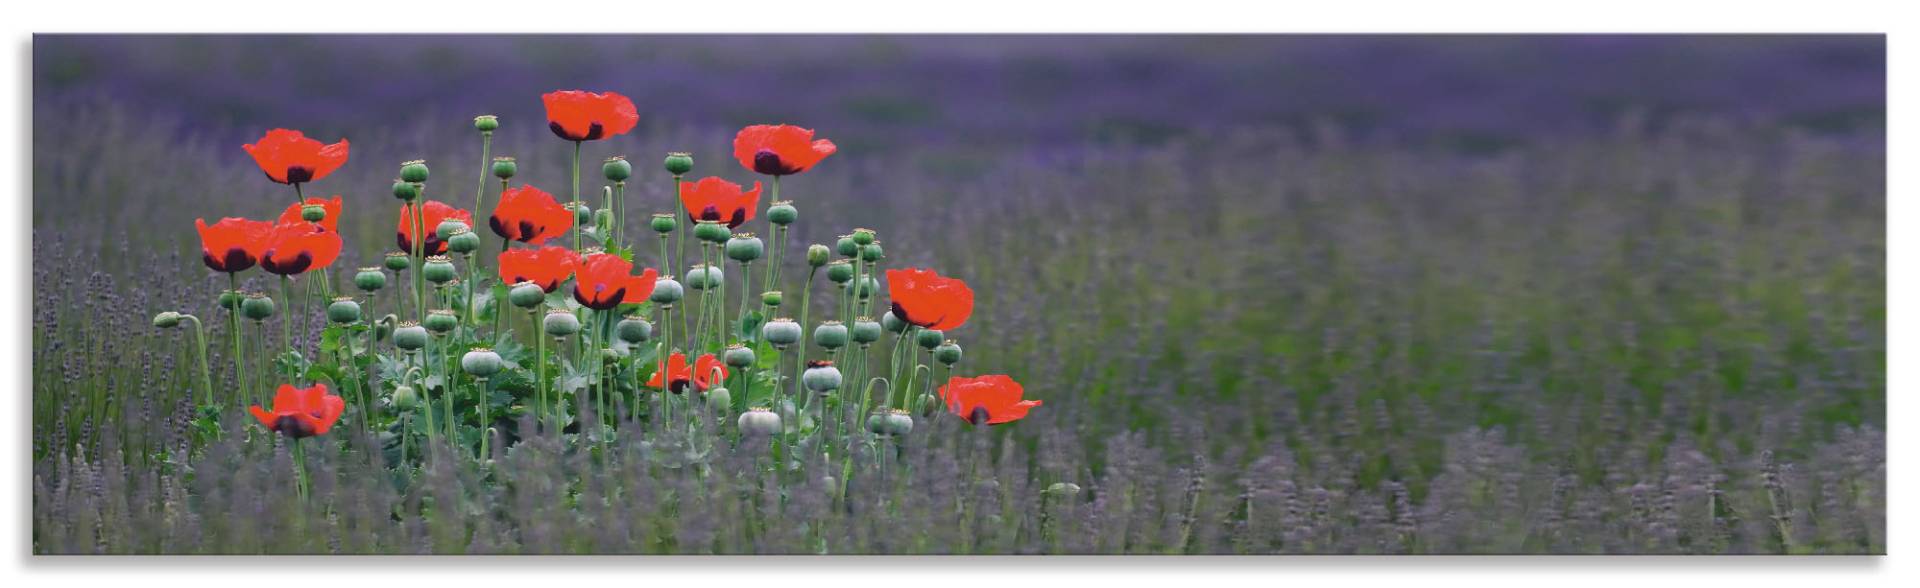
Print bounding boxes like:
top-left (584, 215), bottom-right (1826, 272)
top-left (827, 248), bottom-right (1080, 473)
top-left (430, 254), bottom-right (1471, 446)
top-left (31, 35), bottom-right (1887, 555)
